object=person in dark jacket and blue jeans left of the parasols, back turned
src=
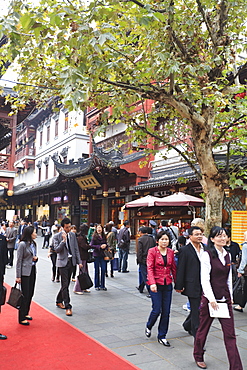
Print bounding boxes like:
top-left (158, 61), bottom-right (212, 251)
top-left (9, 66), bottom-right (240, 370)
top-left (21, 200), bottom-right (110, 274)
top-left (118, 220), bottom-right (130, 272)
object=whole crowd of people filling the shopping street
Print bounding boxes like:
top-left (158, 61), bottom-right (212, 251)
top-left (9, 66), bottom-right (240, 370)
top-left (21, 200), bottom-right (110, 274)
top-left (0, 217), bottom-right (247, 370)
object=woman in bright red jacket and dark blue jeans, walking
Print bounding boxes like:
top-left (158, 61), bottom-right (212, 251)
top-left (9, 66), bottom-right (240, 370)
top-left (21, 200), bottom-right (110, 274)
top-left (145, 231), bottom-right (176, 347)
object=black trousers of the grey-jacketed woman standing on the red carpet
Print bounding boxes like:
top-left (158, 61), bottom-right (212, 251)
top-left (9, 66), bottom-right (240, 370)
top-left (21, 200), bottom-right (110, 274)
top-left (19, 266), bottom-right (36, 322)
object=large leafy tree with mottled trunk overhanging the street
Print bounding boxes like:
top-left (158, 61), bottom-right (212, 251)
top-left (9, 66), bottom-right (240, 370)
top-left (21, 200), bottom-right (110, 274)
top-left (0, 0), bottom-right (247, 231)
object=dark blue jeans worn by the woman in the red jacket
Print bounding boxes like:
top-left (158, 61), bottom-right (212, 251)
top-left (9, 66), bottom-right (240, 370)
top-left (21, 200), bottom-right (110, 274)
top-left (147, 284), bottom-right (172, 339)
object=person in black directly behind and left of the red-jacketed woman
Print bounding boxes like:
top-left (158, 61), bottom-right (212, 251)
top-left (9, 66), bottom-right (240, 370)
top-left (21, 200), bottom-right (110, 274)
top-left (136, 226), bottom-right (156, 298)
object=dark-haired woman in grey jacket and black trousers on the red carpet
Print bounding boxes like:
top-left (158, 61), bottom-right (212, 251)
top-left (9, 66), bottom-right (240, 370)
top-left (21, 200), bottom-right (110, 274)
top-left (16, 226), bottom-right (38, 325)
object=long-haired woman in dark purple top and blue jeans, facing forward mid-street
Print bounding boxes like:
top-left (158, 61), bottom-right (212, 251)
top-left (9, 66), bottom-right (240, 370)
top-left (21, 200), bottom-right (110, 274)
top-left (90, 224), bottom-right (107, 291)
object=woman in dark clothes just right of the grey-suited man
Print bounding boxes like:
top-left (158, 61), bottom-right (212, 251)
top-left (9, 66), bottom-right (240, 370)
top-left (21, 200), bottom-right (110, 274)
top-left (74, 224), bottom-right (90, 294)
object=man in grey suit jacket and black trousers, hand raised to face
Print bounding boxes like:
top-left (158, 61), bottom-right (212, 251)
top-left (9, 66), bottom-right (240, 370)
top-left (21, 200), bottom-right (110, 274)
top-left (53, 217), bottom-right (82, 316)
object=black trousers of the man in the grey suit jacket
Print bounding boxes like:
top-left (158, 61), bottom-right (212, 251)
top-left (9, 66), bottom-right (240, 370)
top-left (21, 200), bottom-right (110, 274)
top-left (56, 258), bottom-right (73, 309)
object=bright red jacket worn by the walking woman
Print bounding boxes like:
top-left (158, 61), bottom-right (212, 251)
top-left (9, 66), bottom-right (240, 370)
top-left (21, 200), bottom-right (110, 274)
top-left (147, 247), bottom-right (177, 285)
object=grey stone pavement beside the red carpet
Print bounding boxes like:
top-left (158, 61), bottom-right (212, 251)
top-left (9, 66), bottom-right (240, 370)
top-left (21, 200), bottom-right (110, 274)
top-left (1, 237), bottom-right (247, 370)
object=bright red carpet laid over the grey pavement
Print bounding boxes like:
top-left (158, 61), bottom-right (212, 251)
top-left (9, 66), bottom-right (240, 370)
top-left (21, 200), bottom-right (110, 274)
top-left (0, 287), bottom-right (138, 370)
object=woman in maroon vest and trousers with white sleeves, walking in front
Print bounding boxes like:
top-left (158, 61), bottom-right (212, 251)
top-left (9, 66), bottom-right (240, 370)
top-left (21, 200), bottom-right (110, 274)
top-left (194, 226), bottom-right (243, 370)
